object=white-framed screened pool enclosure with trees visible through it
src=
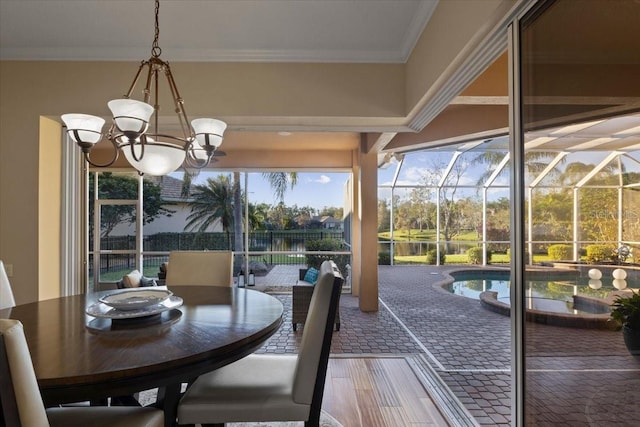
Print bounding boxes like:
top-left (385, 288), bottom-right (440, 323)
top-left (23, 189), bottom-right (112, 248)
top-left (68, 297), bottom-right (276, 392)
top-left (378, 114), bottom-right (640, 265)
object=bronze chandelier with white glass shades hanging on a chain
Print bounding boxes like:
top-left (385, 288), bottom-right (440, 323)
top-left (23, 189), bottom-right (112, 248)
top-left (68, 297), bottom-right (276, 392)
top-left (61, 0), bottom-right (227, 176)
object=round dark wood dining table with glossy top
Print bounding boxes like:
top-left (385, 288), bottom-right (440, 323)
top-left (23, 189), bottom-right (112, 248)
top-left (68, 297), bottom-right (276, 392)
top-left (0, 286), bottom-right (283, 426)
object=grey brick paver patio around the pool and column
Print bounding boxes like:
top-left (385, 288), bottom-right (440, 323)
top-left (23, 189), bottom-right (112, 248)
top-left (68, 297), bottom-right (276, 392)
top-left (256, 266), bottom-right (640, 427)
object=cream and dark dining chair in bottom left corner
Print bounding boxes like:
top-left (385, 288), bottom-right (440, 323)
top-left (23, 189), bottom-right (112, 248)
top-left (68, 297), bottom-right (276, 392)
top-left (0, 319), bottom-right (164, 427)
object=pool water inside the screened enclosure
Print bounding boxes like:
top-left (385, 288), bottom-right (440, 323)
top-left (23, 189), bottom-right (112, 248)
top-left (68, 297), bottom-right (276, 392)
top-left (449, 274), bottom-right (632, 314)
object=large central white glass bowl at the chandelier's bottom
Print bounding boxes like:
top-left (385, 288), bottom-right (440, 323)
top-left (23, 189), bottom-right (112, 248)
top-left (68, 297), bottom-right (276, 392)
top-left (122, 143), bottom-right (185, 176)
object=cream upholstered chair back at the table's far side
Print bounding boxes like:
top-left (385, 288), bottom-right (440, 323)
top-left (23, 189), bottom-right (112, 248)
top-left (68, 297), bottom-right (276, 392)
top-left (165, 251), bottom-right (233, 287)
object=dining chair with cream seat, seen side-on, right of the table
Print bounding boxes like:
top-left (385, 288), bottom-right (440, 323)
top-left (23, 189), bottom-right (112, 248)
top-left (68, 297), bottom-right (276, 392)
top-left (178, 261), bottom-right (343, 427)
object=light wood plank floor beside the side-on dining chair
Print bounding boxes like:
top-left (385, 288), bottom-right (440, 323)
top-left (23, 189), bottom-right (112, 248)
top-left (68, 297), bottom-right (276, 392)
top-left (322, 357), bottom-right (448, 427)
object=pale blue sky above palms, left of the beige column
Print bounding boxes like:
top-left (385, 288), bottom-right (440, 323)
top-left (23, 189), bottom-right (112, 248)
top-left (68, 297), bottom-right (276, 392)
top-left (171, 171), bottom-right (351, 210)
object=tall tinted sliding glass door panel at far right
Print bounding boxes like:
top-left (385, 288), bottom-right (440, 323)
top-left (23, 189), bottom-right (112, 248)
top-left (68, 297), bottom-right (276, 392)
top-left (512, 0), bottom-right (640, 426)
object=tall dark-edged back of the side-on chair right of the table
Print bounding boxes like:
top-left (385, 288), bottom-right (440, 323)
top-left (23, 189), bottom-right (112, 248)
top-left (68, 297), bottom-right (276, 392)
top-left (293, 261), bottom-right (343, 417)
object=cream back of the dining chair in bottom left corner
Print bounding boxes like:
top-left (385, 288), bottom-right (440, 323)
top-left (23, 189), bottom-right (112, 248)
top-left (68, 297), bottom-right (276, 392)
top-left (0, 319), bottom-right (49, 427)
